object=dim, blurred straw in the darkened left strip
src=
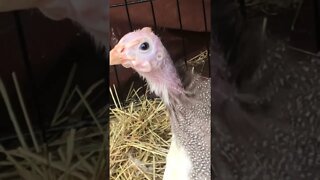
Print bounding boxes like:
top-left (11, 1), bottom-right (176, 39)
top-left (0, 65), bottom-right (107, 180)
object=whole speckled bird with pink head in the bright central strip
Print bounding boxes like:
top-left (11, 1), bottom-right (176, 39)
top-left (110, 27), bottom-right (211, 180)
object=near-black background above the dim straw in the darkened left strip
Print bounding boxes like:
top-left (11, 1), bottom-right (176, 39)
top-left (0, 9), bottom-right (106, 148)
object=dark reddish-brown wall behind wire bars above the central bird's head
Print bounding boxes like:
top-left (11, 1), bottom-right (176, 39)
top-left (110, 0), bottom-right (211, 32)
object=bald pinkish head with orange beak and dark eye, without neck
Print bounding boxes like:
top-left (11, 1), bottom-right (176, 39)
top-left (110, 27), bottom-right (171, 73)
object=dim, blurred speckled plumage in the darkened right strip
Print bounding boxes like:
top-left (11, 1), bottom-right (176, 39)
top-left (214, 39), bottom-right (320, 180)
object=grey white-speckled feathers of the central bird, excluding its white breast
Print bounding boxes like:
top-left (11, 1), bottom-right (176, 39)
top-left (168, 74), bottom-right (211, 180)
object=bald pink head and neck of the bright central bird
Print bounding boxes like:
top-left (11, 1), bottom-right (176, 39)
top-left (110, 27), bottom-right (183, 104)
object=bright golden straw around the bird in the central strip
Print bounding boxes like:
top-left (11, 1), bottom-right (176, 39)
top-left (109, 51), bottom-right (208, 180)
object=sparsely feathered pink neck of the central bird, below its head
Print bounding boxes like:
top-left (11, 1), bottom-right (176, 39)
top-left (140, 60), bottom-right (184, 105)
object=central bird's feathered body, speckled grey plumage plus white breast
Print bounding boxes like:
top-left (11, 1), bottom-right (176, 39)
top-left (164, 74), bottom-right (211, 180)
